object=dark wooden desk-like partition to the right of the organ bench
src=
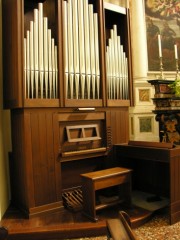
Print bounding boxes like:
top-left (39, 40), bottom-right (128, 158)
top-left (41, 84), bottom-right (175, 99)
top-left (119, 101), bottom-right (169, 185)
top-left (115, 144), bottom-right (180, 224)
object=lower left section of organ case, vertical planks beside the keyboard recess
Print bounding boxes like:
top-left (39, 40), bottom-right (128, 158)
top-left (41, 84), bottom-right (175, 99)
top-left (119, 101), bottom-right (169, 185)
top-left (12, 109), bottom-right (61, 214)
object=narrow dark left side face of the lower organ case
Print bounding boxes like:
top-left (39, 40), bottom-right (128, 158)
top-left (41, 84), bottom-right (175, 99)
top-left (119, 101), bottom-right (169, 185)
top-left (10, 111), bottom-right (29, 208)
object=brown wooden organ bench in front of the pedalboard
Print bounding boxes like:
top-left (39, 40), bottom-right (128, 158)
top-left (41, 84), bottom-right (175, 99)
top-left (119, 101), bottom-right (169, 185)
top-left (81, 167), bottom-right (132, 221)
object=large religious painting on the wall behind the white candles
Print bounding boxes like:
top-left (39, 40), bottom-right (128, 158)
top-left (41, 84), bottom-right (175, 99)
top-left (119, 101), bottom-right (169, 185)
top-left (144, 0), bottom-right (180, 71)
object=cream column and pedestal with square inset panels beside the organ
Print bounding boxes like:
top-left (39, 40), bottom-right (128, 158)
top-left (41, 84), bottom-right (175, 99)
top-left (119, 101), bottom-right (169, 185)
top-left (129, 0), bottom-right (159, 141)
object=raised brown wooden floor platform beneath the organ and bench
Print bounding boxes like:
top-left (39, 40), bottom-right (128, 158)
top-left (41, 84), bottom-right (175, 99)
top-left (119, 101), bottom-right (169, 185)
top-left (0, 206), bottom-right (152, 240)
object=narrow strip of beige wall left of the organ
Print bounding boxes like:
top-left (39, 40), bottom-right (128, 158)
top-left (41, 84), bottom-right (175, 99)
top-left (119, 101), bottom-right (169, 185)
top-left (0, 0), bottom-right (11, 220)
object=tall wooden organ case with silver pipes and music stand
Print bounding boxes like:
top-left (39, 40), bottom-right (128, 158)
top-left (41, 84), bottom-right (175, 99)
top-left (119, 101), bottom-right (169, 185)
top-left (2, 0), bottom-right (133, 217)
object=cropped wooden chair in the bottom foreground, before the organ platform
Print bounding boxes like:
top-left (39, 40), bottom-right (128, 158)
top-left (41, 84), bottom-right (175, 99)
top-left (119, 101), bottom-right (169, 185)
top-left (107, 211), bottom-right (138, 240)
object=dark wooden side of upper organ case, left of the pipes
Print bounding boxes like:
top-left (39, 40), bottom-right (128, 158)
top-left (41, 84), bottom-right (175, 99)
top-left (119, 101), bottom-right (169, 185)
top-left (2, 0), bottom-right (24, 108)
